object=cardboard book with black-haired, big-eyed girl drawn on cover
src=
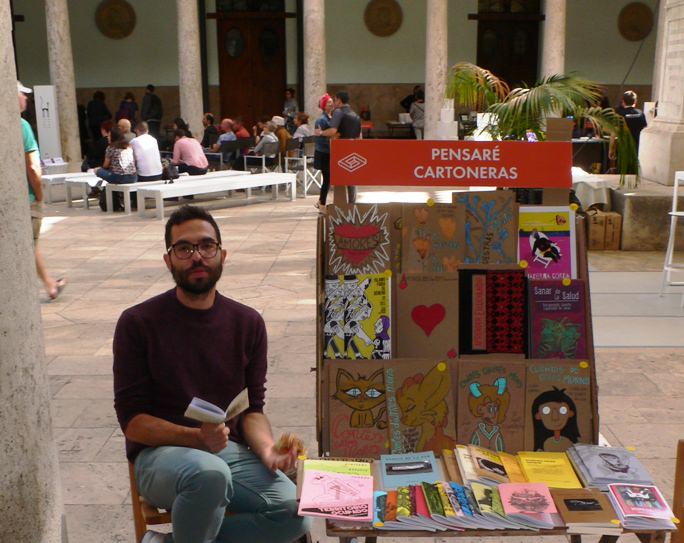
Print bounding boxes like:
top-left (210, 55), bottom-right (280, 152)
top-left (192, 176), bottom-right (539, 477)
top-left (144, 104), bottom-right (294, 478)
top-left (525, 359), bottom-right (593, 452)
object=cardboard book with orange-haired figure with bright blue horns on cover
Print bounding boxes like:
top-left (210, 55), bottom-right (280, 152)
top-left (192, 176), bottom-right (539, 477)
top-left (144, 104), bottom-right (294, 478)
top-left (457, 360), bottom-right (526, 453)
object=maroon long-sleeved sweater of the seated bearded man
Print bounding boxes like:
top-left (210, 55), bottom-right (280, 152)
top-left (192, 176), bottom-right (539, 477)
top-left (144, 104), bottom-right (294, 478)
top-left (114, 289), bottom-right (266, 461)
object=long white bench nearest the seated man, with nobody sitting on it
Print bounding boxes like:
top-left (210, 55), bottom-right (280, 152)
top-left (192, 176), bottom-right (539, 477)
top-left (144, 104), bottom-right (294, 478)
top-left (138, 173), bottom-right (297, 220)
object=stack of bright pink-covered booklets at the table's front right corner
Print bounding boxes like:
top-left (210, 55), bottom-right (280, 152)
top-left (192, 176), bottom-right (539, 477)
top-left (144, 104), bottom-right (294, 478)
top-left (608, 484), bottom-right (676, 530)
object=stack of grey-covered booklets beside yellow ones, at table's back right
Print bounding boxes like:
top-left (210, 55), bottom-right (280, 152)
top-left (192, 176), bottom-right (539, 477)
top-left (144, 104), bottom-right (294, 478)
top-left (567, 443), bottom-right (653, 492)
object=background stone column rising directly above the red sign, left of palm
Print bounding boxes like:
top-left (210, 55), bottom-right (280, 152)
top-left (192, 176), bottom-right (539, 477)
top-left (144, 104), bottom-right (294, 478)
top-left (424, 0), bottom-right (448, 140)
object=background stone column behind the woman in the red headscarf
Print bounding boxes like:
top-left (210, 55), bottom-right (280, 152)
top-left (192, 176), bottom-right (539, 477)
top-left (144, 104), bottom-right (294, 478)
top-left (299, 0), bottom-right (327, 117)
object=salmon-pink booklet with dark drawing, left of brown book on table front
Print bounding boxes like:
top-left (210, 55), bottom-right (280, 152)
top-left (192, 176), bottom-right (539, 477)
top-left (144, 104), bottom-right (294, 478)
top-left (499, 483), bottom-right (560, 529)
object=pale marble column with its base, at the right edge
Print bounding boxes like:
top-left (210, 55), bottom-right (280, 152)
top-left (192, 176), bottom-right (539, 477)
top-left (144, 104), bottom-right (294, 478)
top-left (639, 0), bottom-right (684, 185)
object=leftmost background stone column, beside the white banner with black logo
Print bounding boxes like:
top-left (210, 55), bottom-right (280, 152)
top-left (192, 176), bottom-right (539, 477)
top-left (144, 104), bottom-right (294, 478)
top-left (45, 0), bottom-right (82, 171)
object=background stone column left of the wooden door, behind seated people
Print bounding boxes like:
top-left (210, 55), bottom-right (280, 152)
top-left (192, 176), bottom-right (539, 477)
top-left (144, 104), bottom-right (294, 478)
top-left (176, 0), bottom-right (204, 139)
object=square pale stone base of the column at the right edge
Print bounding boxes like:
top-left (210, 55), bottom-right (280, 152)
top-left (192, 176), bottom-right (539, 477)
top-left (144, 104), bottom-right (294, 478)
top-left (639, 119), bottom-right (684, 186)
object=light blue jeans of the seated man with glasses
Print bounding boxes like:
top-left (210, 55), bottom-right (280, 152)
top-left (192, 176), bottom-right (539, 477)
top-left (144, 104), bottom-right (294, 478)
top-left (135, 441), bottom-right (310, 543)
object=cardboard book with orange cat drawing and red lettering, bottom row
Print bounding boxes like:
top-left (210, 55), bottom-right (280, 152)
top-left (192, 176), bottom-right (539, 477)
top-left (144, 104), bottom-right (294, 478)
top-left (324, 360), bottom-right (389, 458)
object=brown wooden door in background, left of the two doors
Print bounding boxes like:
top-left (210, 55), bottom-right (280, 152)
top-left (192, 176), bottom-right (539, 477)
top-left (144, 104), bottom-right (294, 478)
top-left (217, 13), bottom-right (286, 128)
